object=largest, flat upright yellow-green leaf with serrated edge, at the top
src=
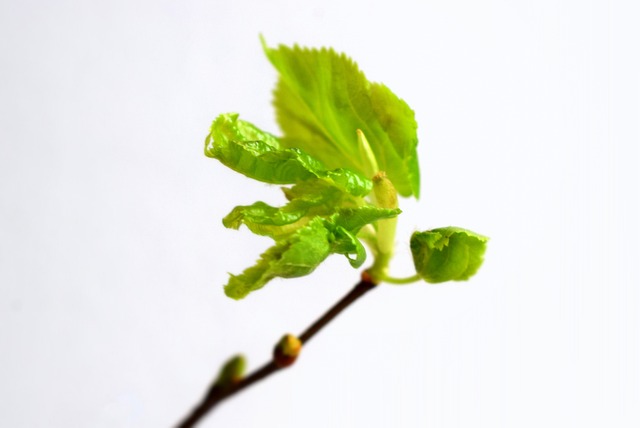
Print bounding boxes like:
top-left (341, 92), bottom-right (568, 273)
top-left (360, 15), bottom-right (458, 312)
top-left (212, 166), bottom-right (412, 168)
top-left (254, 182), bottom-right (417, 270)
top-left (263, 40), bottom-right (420, 198)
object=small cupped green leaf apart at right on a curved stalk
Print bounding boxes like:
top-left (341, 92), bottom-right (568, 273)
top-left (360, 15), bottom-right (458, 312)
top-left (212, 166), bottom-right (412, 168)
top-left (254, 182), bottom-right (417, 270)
top-left (411, 227), bottom-right (489, 283)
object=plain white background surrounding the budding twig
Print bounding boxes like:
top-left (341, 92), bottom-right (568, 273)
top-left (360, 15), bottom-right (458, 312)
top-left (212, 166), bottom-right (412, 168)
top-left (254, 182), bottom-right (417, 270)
top-left (0, 0), bottom-right (640, 428)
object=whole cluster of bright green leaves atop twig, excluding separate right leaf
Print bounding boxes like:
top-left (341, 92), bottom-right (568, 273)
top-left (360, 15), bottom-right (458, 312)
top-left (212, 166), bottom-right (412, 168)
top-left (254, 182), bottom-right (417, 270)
top-left (205, 41), bottom-right (440, 299)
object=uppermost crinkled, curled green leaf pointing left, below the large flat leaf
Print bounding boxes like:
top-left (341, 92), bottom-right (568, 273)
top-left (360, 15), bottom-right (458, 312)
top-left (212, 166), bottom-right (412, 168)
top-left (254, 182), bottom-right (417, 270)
top-left (205, 113), bottom-right (371, 196)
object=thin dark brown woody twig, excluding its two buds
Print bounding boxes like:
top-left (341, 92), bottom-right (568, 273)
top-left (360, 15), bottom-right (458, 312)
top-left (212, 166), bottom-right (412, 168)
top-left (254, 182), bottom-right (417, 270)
top-left (172, 271), bottom-right (377, 428)
